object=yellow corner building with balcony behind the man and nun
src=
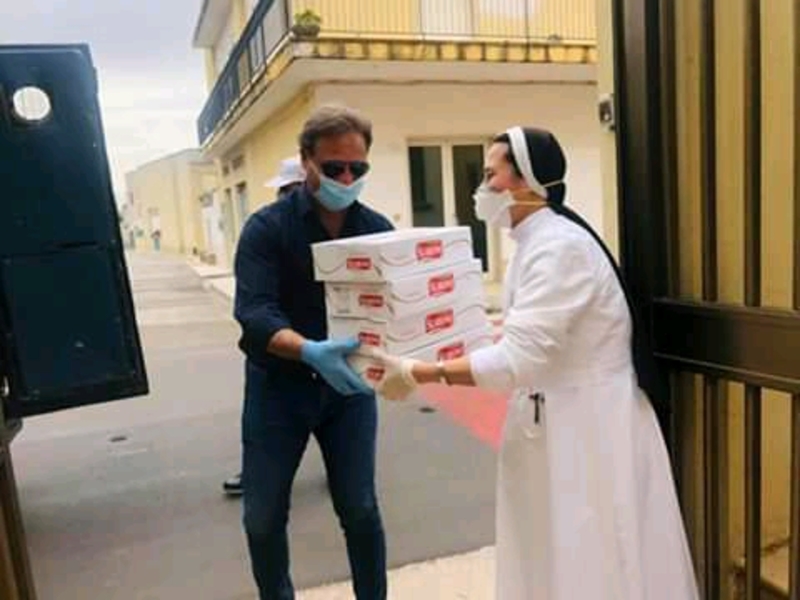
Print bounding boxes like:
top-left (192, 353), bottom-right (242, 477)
top-left (195, 0), bottom-right (604, 279)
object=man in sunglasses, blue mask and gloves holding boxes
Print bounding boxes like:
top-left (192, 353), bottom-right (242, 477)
top-left (235, 107), bottom-right (392, 600)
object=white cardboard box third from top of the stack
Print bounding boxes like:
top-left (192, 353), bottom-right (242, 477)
top-left (328, 300), bottom-right (489, 355)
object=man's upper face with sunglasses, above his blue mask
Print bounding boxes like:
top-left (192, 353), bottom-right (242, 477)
top-left (303, 132), bottom-right (369, 191)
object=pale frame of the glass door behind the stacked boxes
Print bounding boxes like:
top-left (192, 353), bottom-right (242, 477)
top-left (404, 136), bottom-right (503, 282)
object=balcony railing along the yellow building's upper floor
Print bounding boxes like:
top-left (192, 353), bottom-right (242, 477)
top-left (197, 0), bottom-right (596, 144)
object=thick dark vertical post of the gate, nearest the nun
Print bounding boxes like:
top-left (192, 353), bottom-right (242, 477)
top-left (611, 0), bottom-right (675, 436)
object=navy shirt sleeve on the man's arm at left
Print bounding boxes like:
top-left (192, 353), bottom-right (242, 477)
top-left (234, 215), bottom-right (291, 353)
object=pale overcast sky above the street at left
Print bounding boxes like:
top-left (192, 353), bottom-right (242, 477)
top-left (0, 0), bottom-right (206, 196)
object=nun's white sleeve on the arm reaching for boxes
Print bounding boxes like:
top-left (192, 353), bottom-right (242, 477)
top-left (470, 236), bottom-right (598, 390)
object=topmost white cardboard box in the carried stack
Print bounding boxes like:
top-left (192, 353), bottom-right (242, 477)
top-left (311, 227), bottom-right (473, 282)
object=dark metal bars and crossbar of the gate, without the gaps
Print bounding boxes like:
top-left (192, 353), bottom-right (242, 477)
top-left (610, 0), bottom-right (800, 600)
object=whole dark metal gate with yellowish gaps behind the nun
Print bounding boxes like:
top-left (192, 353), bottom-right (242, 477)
top-left (613, 0), bottom-right (800, 600)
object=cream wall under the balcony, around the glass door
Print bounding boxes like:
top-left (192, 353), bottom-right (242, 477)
top-left (315, 83), bottom-right (604, 274)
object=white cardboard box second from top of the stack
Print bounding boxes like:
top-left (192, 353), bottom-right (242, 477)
top-left (325, 259), bottom-right (485, 320)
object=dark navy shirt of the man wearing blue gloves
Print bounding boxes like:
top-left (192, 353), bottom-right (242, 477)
top-left (234, 187), bottom-right (393, 385)
